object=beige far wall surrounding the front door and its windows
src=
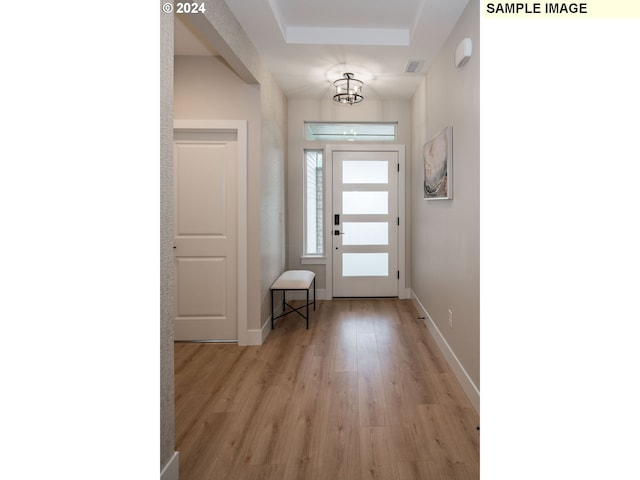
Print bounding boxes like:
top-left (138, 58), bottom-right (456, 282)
top-left (287, 98), bottom-right (411, 289)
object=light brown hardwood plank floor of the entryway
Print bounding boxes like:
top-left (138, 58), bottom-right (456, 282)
top-left (175, 299), bottom-right (480, 480)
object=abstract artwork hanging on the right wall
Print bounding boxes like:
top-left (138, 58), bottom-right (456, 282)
top-left (422, 127), bottom-right (453, 200)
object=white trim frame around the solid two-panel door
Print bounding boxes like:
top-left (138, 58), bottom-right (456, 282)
top-left (173, 120), bottom-right (249, 346)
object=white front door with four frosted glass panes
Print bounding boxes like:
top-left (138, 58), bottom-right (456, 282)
top-left (332, 151), bottom-right (399, 297)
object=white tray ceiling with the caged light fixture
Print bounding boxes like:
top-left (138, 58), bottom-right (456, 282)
top-left (175, 0), bottom-right (469, 101)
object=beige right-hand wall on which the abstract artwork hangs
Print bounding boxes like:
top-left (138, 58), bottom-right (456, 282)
top-left (411, 0), bottom-right (480, 390)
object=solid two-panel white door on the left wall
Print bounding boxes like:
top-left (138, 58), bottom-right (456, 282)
top-left (174, 134), bottom-right (238, 341)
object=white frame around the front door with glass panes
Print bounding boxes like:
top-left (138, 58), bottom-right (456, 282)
top-left (324, 143), bottom-right (410, 299)
